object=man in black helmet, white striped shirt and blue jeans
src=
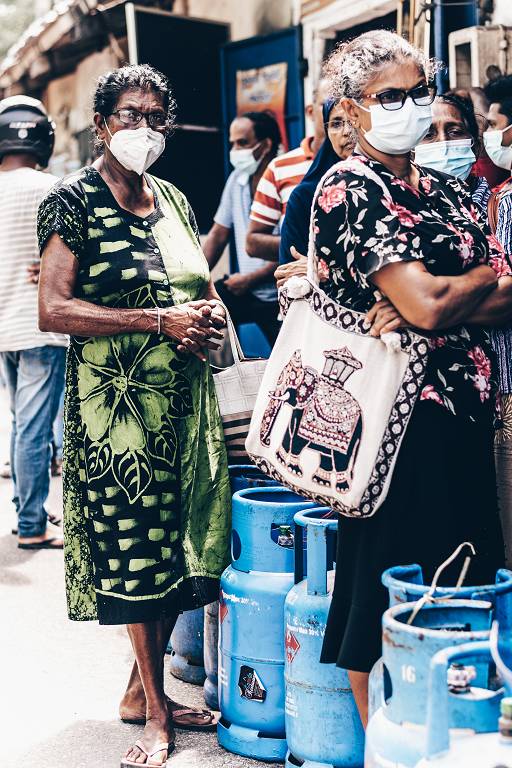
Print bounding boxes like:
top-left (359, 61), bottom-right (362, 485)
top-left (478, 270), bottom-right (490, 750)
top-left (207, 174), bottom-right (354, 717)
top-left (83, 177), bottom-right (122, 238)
top-left (0, 96), bottom-right (67, 549)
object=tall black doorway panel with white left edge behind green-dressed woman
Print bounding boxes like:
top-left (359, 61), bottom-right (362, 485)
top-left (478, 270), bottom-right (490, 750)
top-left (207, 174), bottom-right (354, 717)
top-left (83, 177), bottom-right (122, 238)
top-left (126, 3), bottom-right (230, 233)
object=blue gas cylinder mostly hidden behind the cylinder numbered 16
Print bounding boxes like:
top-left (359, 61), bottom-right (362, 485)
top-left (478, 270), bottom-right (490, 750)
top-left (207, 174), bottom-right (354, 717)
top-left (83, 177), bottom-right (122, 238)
top-left (368, 564), bottom-right (512, 717)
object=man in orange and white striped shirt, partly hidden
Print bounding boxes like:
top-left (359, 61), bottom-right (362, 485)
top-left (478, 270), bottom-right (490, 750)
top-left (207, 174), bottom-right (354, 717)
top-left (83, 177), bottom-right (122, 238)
top-left (246, 80), bottom-right (327, 261)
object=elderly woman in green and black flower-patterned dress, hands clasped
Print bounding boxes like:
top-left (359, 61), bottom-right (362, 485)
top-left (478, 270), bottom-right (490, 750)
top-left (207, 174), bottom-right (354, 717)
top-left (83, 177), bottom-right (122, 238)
top-left (38, 65), bottom-right (230, 766)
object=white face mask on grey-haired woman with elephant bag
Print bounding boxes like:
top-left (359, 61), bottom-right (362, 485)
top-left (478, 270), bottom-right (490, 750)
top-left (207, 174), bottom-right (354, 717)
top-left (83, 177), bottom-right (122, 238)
top-left (356, 96), bottom-right (432, 155)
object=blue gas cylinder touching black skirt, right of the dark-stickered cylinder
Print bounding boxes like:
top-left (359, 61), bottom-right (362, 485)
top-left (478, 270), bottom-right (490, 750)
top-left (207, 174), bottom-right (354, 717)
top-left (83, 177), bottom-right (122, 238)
top-left (285, 508), bottom-right (364, 768)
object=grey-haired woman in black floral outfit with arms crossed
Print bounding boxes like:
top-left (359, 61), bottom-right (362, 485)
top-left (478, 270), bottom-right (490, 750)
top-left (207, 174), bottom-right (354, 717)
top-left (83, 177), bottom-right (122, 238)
top-left (314, 31), bottom-right (506, 723)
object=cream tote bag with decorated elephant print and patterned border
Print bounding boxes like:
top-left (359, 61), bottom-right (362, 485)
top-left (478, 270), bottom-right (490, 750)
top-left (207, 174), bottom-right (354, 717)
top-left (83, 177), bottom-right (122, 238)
top-left (246, 164), bottom-right (428, 517)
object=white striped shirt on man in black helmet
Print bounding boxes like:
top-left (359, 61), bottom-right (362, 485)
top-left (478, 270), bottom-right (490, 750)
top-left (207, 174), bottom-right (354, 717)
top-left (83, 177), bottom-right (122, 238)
top-left (0, 168), bottom-right (68, 352)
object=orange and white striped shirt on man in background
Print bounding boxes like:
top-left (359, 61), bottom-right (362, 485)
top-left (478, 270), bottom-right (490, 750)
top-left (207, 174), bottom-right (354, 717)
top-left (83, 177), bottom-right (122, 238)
top-left (250, 136), bottom-right (313, 227)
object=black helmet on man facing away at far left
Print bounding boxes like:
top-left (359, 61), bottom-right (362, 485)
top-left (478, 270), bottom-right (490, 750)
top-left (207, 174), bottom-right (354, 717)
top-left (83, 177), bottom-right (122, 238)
top-left (0, 96), bottom-right (55, 168)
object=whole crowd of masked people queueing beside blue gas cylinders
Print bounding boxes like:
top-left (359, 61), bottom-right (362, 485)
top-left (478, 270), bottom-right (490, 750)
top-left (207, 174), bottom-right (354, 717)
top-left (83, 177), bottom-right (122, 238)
top-left (0, 25), bottom-right (512, 766)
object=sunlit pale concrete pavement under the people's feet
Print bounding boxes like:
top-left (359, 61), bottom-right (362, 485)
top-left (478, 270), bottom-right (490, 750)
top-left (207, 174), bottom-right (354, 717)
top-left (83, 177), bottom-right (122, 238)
top-left (0, 390), bottom-right (277, 768)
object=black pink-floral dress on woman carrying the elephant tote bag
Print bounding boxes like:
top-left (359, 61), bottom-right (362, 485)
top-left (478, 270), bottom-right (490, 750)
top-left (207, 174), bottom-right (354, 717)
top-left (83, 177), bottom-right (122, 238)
top-left (314, 155), bottom-right (510, 671)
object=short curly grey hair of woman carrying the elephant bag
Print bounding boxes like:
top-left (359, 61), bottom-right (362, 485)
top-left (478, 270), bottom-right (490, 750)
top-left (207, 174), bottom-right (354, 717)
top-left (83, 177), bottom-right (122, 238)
top-left (323, 29), bottom-right (442, 100)
